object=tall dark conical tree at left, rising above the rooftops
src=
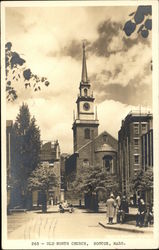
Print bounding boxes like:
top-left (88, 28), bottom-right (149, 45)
top-left (11, 104), bottom-right (41, 206)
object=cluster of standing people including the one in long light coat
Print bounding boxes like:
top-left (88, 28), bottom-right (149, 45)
top-left (106, 193), bottom-right (129, 224)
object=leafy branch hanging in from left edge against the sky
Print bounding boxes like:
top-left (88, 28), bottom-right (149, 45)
top-left (5, 42), bottom-right (50, 101)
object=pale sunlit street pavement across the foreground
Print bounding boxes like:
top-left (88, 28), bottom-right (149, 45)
top-left (8, 206), bottom-right (152, 240)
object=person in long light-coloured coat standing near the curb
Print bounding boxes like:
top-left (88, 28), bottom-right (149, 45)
top-left (106, 193), bottom-right (116, 224)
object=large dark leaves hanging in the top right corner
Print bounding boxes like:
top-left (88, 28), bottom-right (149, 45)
top-left (123, 5), bottom-right (152, 38)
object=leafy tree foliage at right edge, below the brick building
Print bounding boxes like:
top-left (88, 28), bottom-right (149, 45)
top-left (133, 167), bottom-right (153, 192)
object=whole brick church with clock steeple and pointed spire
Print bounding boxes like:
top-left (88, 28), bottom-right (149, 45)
top-left (65, 44), bottom-right (118, 193)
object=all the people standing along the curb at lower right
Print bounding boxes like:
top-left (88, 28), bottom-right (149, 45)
top-left (106, 193), bottom-right (153, 227)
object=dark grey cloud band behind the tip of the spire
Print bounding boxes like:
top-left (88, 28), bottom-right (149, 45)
top-left (53, 18), bottom-right (151, 60)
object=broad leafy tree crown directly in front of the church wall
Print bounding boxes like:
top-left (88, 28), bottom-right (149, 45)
top-left (69, 166), bottom-right (119, 198)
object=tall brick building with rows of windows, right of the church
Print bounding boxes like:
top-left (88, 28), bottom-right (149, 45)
top-left (118, 111), bottom-right (153, 196)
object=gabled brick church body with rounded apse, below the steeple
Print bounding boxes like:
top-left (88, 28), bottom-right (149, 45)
top-left (66, 131), bottom-right (118, 186)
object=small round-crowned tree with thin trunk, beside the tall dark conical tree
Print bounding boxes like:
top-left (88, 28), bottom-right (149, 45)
top-left (27, 163), bottom-right (59, 212)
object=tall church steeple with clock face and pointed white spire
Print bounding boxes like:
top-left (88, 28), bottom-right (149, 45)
top-left (72, 43), bottom-right (99, 152)
